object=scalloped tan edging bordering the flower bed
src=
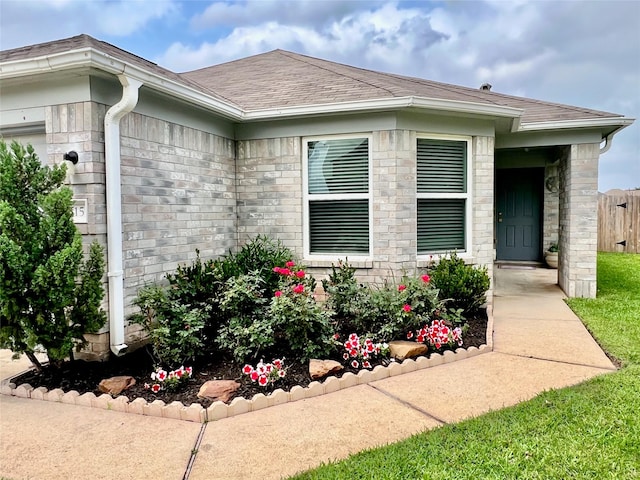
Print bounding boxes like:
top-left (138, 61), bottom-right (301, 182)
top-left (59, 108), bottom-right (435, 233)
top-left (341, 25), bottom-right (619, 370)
top-left (0, 306), bottom-right (493, 423)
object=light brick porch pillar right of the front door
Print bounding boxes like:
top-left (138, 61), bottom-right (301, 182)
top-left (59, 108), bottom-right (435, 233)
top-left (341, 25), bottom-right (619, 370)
top-left (558, 144), bottom-right (600, 298)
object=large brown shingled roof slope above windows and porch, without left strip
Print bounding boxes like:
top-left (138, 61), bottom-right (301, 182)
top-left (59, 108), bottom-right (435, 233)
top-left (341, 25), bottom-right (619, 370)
top-left (181, 50), bottom-right (622, 123)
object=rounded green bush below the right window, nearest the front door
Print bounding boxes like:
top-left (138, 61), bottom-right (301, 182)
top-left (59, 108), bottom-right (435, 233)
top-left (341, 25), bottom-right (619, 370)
top-left (428, 252), bottom-right (490, 316)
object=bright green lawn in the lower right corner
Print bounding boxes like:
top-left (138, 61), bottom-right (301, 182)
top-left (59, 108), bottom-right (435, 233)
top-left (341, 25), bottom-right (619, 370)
top-left (293, 254), bottom-right (640, 480)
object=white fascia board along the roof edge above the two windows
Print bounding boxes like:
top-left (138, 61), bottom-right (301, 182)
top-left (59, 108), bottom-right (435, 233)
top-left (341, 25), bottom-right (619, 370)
top-left (243, 96), bottom-right (524, 120)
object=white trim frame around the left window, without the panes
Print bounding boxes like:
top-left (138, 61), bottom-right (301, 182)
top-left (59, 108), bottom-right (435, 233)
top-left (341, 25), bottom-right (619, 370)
top-left (302, 132), bottom-right (374, 262)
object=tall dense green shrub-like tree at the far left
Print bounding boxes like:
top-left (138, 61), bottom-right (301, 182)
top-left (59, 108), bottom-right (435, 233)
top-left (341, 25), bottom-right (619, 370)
top-left (0, 140), bottom-right (106, 369)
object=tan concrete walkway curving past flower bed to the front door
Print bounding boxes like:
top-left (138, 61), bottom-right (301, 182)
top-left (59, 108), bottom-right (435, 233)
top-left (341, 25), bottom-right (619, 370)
top-left (0, 269), bottom-right (615, 480)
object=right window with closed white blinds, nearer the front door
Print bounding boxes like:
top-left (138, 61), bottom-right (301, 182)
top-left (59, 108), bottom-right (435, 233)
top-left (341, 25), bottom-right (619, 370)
top-left (417, 138), bottom-right (469, 255)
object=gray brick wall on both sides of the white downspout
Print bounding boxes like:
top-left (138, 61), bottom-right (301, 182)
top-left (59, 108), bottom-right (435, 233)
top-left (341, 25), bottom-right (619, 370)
top-left (45, 102), bottom-right (237, 359)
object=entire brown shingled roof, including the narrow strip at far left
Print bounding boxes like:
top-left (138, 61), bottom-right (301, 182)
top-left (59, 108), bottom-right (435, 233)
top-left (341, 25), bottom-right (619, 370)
top-left (0, 35), bottom-right (624, 124)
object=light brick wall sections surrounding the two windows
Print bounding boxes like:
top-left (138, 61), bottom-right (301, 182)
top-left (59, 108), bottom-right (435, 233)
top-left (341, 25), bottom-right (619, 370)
top-left (237, 130), bottom-right (494, 283)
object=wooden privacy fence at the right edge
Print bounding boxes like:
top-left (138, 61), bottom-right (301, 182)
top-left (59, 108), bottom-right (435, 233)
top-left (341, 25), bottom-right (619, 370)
top-left (598, 190), bottom-right (640, 253)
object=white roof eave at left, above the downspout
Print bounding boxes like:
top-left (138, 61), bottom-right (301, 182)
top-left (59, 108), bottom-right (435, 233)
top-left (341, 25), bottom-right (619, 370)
top-left (0, 47), bottom-right (244, 121)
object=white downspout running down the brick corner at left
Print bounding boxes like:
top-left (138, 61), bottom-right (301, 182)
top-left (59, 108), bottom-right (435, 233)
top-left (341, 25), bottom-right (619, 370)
top-left (104, 74), bottom-right (142, 356)
